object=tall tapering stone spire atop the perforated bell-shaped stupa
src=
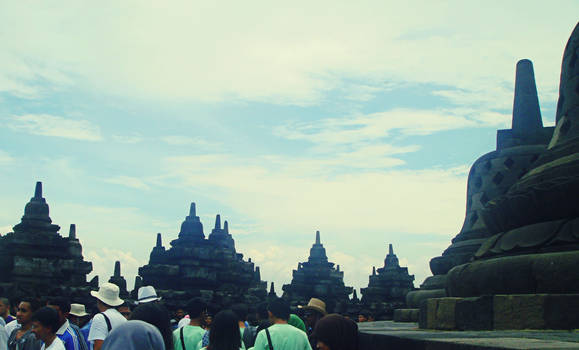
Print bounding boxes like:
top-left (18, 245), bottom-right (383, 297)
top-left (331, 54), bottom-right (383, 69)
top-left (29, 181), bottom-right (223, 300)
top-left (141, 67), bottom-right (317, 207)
top-left (512, 59), bottom-right (543, 137)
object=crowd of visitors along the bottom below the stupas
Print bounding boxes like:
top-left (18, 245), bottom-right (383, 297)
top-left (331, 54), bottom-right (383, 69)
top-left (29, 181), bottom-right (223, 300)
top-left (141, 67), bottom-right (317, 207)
top-left (0, 283), bottom-right (358, 350)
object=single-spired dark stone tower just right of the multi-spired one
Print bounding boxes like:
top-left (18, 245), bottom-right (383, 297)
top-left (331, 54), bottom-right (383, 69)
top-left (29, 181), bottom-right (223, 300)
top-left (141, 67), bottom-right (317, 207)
top-left (282, 231), bottom-right (353, 312)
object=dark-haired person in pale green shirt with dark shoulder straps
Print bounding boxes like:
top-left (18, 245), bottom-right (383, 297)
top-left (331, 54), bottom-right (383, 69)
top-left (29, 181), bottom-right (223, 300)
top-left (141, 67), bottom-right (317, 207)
top-left (253, 298), bottom-right (312, 350)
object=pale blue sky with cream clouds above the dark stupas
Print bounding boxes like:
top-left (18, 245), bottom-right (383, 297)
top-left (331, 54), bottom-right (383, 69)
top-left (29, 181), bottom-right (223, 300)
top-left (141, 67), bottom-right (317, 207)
top-left (0, 0), bottom-right (579, 294)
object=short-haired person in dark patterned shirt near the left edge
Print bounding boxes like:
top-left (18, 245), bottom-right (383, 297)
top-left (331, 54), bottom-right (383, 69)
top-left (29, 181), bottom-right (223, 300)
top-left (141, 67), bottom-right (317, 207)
top-left (8, 298), bottom-right (42, 350)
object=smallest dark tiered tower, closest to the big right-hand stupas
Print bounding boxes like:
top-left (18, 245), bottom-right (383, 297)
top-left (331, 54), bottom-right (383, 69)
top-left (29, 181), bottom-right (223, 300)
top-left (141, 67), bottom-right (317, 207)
top-left (361, 244), bottom-right (414, 305)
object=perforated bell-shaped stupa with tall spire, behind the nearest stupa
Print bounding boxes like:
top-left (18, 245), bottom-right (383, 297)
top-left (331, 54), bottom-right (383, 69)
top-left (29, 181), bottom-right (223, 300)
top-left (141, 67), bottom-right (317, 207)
top-left (407, 60), bottom-right (554, 307)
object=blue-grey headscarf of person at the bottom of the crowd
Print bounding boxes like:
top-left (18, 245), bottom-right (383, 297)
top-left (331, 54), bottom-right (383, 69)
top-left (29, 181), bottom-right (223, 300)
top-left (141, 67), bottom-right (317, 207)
top-left (102, 320), bottom-right (164, 350)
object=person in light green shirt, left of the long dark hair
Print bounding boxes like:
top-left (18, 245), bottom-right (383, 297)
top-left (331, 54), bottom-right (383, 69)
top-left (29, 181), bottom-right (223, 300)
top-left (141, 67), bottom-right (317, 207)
top-left (173, 298), bottom-right (207, 350)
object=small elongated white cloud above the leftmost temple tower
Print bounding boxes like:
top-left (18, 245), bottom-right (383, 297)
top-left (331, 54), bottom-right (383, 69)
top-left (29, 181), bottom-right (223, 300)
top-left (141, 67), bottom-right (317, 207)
top-left (6, 114), bottom-right (102, 141)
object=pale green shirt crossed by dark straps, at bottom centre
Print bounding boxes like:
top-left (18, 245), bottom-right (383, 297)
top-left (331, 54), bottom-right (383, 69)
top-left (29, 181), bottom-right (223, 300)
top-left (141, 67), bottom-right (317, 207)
top-left (252, 324), bottom-right (312, 350)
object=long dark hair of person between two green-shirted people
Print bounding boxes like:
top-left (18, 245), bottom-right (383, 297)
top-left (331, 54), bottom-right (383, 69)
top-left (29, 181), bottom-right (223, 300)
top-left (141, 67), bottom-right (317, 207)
top-left (207, 310), bottom-right (241, 350)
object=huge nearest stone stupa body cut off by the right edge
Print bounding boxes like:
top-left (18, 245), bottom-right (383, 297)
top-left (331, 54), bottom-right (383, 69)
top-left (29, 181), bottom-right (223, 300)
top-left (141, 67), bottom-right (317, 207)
top-left (448, 25), bottom-right (579, 296)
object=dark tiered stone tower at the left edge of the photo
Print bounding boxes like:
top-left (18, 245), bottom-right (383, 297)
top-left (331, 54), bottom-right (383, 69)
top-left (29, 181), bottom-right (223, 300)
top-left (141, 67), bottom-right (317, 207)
top-left (0, 182), bottom-right (98, 300)
